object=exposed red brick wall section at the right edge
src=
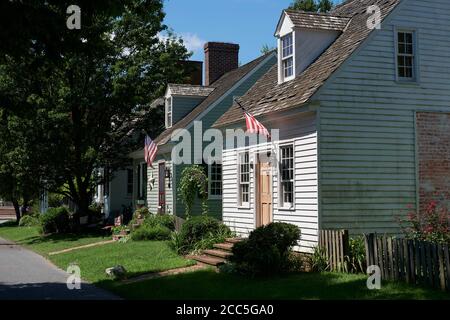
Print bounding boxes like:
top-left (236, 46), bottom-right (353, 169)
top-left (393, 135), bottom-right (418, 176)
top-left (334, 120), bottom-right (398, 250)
top-left (417, 112), bottom-right (450, 212)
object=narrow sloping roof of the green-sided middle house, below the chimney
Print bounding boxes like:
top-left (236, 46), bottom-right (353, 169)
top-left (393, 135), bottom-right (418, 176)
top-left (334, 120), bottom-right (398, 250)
top-left (155, 51), bottom-right (274, 145)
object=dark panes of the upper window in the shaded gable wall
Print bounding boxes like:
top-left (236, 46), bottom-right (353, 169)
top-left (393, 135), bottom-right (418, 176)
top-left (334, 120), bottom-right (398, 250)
top-left (397, 31), bottom-right (415, 80)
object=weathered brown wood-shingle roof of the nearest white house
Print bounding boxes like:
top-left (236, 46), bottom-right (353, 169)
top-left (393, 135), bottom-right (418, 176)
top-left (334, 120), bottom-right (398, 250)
top-left (213, 0), bottom-right (401, 127)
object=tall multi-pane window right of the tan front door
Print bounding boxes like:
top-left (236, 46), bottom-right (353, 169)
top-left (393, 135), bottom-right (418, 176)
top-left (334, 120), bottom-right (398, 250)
top-left (280, 145), bottom-right (294, 207)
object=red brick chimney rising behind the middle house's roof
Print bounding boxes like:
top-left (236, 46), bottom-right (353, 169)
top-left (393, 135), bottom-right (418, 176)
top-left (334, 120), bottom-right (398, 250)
top-left (205, 42), bottom-right (239, 86)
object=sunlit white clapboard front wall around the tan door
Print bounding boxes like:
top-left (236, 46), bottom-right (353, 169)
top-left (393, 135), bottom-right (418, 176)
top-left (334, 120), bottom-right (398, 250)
top-left (222, 113), bottom-right (318, 251)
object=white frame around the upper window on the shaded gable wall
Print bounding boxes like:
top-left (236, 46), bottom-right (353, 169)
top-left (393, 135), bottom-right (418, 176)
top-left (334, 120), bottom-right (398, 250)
top-left (394, 27), bottom-right (419, 83)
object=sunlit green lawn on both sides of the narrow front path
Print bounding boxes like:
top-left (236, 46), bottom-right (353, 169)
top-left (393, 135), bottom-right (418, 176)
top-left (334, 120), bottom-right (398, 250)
top-left (0, 225), bottom-right (195, 288)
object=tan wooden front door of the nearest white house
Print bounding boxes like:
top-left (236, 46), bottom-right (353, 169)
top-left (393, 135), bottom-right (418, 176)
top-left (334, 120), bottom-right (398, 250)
top-left (256, 156), bottom-right (273, 227)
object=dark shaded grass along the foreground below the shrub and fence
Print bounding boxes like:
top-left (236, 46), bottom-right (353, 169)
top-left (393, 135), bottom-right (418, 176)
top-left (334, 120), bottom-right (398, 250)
top-left (114, 270), bottom-right (450, 300)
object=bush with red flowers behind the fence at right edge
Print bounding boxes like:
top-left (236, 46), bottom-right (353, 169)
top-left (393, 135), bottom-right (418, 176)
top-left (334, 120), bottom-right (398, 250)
top-left (401, 201), bottom-right (450, 243)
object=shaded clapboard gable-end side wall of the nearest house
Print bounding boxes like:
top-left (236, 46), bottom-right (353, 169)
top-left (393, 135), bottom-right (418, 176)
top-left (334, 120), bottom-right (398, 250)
top-left (316, 0), bottom-right (450, 233)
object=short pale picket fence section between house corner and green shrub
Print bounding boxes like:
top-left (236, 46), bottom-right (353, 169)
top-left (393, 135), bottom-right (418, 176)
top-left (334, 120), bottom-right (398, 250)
top-left (319, 230), bottom-right (349, 271)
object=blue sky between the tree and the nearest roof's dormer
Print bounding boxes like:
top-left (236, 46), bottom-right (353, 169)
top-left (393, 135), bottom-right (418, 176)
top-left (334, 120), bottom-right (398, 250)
top-left (164, 0), bottom-right (338, 63)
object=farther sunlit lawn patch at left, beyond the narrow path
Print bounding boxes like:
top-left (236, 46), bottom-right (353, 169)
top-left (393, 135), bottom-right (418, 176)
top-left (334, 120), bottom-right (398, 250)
top-left (0, 225), bottom-right (111, 256)
